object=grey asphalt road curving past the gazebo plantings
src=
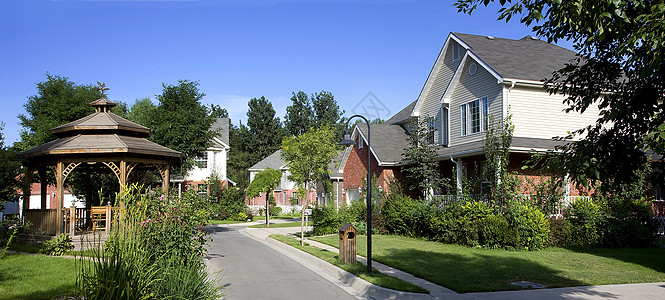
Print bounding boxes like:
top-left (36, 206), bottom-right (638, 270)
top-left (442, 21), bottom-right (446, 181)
top-left (207, 226), bottom-right (356, 300)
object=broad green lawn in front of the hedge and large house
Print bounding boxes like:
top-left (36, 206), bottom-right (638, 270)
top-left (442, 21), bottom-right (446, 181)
top-left (312, 235), bottom-right (665, 292)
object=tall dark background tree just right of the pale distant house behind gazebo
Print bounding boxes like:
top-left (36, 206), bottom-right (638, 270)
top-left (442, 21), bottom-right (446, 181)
top-left (244, 96), bottom-right (285, 166)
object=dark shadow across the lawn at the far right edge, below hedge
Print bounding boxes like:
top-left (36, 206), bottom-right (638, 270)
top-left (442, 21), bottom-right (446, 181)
top-left (563, 247), bottom-right (665, 273)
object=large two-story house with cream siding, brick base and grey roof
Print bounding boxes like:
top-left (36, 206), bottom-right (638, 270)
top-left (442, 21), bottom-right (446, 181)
top-left (342, 33), bottom-right (599, 202)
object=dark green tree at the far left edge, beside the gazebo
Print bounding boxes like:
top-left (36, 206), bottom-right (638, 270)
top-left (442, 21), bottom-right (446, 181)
top-left (0, 122), bottom-right (21, 211)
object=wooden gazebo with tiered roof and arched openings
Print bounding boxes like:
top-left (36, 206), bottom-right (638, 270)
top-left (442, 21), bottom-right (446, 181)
top-left (19, 88), bottom-right (180, 234)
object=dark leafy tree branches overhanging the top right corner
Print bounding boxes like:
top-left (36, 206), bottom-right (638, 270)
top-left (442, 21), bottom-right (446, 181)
top-left (456, 0), bottom-right (665, 193)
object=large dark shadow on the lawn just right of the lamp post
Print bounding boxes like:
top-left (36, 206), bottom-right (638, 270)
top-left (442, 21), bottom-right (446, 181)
top-left (374, 249), bottom-right (585, 293)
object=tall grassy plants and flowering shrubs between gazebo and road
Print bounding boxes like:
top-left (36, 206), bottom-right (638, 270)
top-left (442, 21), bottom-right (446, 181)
top-left (77, 185), bottom-right (219, 299)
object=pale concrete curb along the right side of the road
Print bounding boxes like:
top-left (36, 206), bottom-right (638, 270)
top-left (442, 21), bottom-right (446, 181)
top-left (239, 229), bottom-right (436, 300)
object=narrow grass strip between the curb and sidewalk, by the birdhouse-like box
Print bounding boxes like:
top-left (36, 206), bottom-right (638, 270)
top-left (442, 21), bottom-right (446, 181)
top-left (270, 234), bottom-right (428, 293)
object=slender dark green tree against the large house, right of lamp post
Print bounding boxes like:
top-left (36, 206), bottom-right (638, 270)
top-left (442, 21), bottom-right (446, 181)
top-left (400, 117), bottom-right (441, 197)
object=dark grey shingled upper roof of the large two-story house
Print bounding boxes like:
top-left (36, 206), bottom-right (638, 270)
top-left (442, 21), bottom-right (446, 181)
top-left (452, 32), bottom-right (576, 81)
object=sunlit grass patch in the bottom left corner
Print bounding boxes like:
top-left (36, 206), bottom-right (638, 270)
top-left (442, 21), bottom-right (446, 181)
top-left (0, 254), bottom-right (76, 299)
